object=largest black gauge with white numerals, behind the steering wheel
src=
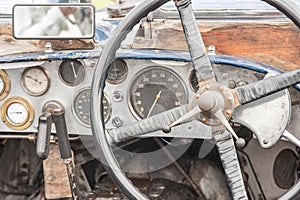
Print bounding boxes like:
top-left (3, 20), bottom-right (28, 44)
top-left (130, 67), bottom-right (187, 118)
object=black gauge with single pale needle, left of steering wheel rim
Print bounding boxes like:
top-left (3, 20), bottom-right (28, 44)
top-left (58, 60), bottom-right (84, 86)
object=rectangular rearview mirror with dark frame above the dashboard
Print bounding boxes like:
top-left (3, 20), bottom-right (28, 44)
top-left (13, 4), bottom-right (95, 39)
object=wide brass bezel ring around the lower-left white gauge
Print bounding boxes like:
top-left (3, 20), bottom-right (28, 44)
top-left (1, 96), bottom-right (34, 130)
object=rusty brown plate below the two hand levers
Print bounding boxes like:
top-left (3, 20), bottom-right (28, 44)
top-left (43, 145), bottom-right (72, 199)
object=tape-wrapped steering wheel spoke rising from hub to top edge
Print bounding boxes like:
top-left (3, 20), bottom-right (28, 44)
top-left (174, 0), bottom-right (215, 82)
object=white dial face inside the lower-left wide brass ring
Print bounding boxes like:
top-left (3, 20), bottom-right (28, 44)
top-left (7, 103), bottom-right (28, 124)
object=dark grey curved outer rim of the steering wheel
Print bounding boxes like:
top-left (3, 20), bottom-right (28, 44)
top-left (91, 0), bottom-right (300, 200)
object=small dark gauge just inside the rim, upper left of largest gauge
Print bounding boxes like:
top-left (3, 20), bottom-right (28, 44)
top-left (106, 59), bottom-right (128, 84)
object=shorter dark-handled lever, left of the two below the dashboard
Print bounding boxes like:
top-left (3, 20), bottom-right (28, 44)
top-left (36, 111), bottom-right (53, 160)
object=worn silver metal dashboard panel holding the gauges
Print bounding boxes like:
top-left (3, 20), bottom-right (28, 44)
top-left (0, 52), bottom-right (263, 138)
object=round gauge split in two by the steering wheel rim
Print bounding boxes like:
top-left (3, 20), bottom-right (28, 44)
top-left (73, 88), bottom-right (111, 127)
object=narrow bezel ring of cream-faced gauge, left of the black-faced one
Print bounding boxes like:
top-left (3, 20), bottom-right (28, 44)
top-left (21, 66), bottom-right (51, 97)
